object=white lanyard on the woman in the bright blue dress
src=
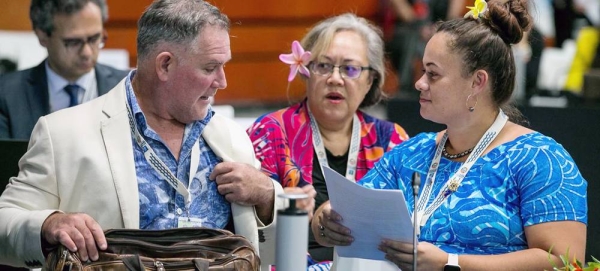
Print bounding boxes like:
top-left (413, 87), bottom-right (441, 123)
top-left (417, 110), bottom-right (508, 226)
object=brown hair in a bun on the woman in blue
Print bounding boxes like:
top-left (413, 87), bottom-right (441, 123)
top-left (436, 0), bottom-right (532, 121)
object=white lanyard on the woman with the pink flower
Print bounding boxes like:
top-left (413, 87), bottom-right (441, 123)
top-left (306, 107), bottom-right (360, 181)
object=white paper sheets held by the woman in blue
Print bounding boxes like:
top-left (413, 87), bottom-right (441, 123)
top-left (323, 167), bottom-right (413, 260)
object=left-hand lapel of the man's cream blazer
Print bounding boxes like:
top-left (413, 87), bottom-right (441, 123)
top-left (101, 79), bottom-right (140, 229)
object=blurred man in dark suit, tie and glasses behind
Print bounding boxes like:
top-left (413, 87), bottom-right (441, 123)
top-left (0, 0), bottom-right (127, 139)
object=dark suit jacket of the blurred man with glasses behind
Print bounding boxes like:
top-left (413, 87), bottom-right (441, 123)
top-left (0, 61), bottom-right (128, 140)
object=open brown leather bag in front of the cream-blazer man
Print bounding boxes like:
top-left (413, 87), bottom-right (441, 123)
top-left (44, 228), bottom-right (260, 271)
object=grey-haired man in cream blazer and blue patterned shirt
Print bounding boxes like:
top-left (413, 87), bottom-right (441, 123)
top-left (0, 0), bottom-right (296, 270)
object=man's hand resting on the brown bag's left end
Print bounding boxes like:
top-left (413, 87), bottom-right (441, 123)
top-left (42, 213), bottom-right (107, 261)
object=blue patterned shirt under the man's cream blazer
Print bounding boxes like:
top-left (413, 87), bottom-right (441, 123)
top-left (125, 71), bottom-right (231, 229)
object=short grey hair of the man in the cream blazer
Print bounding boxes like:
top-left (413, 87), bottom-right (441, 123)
top-left (137, 0), bottom-right (230, 59)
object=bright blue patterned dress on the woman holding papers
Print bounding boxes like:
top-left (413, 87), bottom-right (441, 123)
top-left (359, 132), bottom-right (587, 254)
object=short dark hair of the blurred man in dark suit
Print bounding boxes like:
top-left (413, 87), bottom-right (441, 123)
top-left (29, 0), bottom-right (108, 36)
